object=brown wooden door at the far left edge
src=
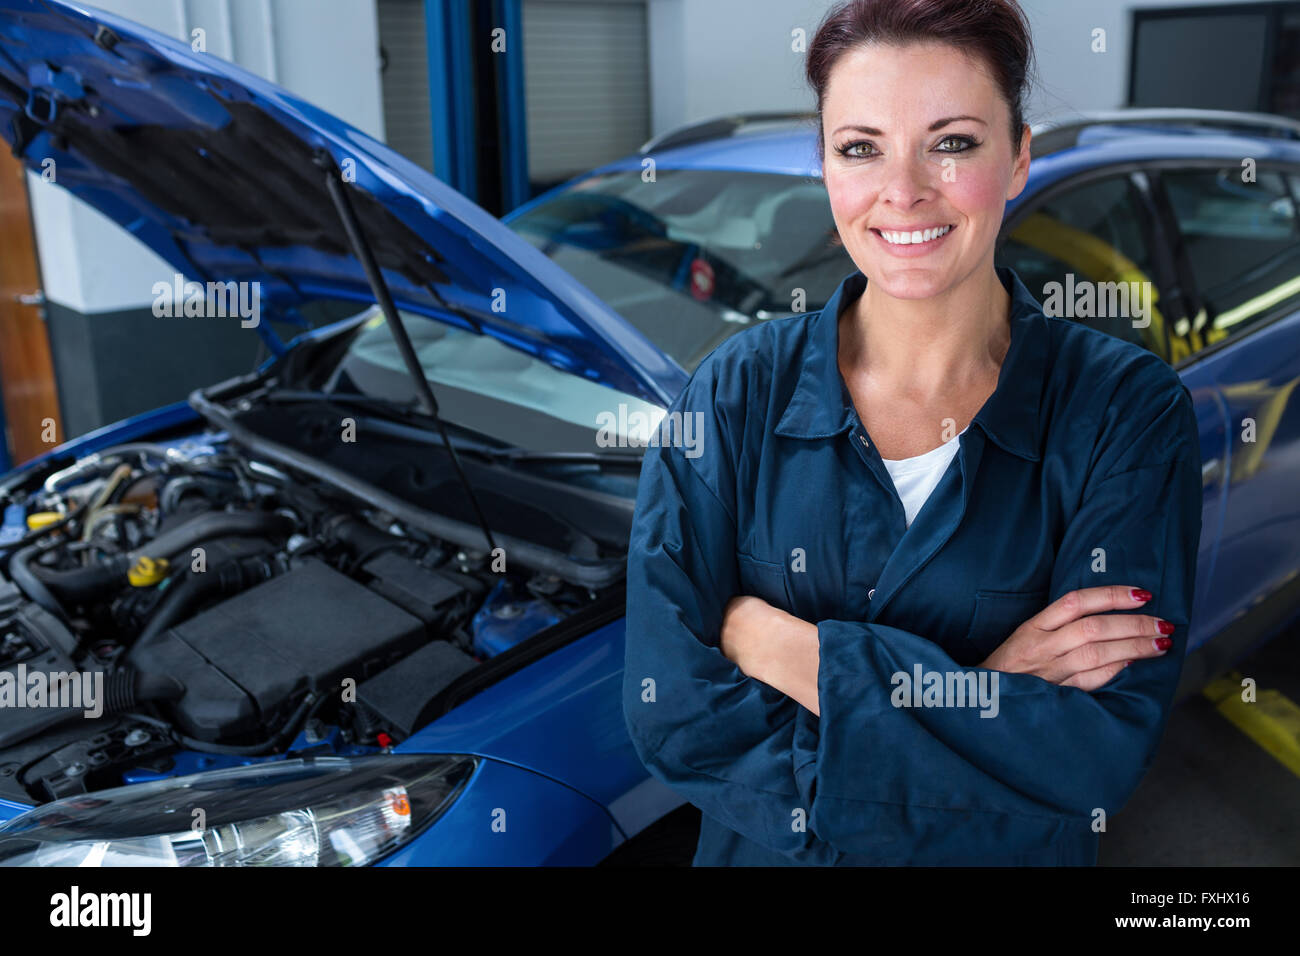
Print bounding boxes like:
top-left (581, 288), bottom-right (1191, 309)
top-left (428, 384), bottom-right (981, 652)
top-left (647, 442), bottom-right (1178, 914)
top-left (0, 143), bottom-right (65, 464)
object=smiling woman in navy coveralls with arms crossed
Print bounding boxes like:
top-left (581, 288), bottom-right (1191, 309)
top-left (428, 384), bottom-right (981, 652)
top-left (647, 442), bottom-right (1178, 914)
top-left (624, 0), bottom-right (1200, 865)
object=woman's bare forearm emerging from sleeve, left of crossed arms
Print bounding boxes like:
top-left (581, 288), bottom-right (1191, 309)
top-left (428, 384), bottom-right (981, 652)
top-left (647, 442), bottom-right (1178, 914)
top-left (719, 594), bottom-right (822, 715)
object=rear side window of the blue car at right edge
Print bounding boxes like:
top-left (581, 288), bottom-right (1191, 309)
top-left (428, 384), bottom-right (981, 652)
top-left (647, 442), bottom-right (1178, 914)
top-left (1161, 165), bottom-right (1300, 354)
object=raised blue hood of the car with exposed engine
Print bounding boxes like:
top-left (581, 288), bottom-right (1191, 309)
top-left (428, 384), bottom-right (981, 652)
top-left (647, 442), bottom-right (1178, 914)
top-left (0, 0), bottom-right (686, 405)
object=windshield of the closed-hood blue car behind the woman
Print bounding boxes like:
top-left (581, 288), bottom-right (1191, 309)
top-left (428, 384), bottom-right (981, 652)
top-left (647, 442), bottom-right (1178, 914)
top-left (507, 168), bottom-right (855, 372)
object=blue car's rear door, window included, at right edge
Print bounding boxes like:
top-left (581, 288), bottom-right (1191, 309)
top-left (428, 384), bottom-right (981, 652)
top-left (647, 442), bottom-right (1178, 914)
top-left (1154, 159), bottom-right (1300, 654)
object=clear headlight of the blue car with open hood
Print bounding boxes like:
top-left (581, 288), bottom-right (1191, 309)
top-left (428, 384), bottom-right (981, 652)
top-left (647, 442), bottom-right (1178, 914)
top-left (0, 754), bottom-right (478, 866)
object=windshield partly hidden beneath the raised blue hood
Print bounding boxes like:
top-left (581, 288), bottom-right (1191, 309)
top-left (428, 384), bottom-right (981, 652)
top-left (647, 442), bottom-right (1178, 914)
top-left (325, 306), bottom-right (666, 451)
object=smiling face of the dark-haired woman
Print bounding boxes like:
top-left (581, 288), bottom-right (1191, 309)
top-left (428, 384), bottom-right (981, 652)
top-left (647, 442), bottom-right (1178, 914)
top-left (822, 43), bottom-right (1030, 299)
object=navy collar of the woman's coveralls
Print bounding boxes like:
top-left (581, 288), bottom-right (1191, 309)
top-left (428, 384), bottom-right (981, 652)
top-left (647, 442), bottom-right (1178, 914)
top-left (776, 267), bottom-right (1048, 462)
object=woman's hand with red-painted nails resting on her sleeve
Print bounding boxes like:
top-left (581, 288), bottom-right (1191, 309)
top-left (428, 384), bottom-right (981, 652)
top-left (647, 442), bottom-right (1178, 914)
top-left (979, 585), bottom-right (1174, 691)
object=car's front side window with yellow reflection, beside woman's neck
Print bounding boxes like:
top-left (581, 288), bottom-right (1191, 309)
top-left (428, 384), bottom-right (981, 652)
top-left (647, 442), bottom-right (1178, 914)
top-left (997, 176), bottom-right (1171, 362)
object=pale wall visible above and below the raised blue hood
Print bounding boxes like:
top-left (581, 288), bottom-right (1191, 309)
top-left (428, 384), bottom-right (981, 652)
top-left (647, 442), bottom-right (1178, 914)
top-left (27, 0), bottom-right (384, 312)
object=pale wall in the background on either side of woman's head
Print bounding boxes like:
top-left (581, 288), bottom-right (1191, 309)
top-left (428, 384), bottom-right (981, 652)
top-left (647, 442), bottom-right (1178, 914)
top-left (649, 0), bottom-right (1263, 135)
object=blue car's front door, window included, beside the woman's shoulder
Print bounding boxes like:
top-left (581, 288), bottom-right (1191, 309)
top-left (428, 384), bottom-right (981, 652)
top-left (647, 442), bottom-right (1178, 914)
top-left (997, 168), bottom-right (1227, 648)
